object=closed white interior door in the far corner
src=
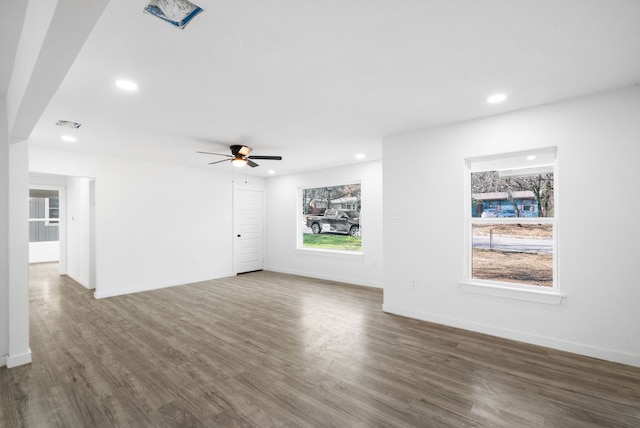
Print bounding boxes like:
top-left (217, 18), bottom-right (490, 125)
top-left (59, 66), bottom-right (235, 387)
top-left (233, 189), bottom-right (264, 273)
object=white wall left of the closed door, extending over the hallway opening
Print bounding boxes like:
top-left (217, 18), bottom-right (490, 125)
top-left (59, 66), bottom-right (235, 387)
top-left (30, 146), bottom-right (264, 298)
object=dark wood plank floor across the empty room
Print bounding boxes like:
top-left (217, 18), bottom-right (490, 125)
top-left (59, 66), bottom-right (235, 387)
top-left (0, 264), bottom-right (640, 428)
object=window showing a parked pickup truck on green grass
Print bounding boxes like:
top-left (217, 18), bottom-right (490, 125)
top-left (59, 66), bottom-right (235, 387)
top-left (298, 183), bottom-right (362, 253)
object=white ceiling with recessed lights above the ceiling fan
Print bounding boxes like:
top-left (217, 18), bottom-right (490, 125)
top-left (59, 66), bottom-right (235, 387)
top-left (22, 0), bottom-right (640, 176)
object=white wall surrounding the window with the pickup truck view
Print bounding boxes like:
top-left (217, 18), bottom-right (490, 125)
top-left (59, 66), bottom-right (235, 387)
top-left (265, 161), bottom-right (382, 287)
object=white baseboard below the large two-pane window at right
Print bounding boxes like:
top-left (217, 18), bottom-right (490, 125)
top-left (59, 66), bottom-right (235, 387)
top-left (382, 304), bottom-right (640, 367)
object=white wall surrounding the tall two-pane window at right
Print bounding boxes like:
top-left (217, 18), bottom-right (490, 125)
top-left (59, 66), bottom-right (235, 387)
top-left (383, 86), bottom-right (640, 366)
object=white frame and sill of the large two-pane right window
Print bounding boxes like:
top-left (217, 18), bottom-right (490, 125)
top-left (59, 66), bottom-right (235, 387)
top-left (459, 147), bottom-right (566, 305)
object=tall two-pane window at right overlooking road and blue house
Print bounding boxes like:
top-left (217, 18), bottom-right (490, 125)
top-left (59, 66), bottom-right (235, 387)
top-left (463, 148), bottom-right (559, 303)
